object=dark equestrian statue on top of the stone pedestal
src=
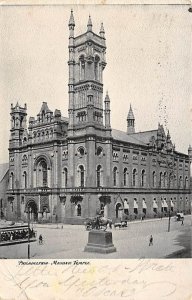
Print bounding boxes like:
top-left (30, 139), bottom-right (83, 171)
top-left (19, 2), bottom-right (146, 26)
top-left (84, 216), bottom-right (112, 231)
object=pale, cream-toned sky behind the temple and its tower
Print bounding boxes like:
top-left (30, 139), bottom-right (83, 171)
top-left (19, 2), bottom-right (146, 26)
top-left (0, 5), bottom-right (192, 163)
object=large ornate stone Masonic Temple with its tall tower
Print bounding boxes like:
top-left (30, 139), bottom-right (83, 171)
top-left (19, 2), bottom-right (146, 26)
top-left (7, 12), bottom-right (192, 224)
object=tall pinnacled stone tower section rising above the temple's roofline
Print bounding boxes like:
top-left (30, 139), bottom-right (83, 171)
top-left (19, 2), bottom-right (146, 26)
top-left (68, 11), bottom-right (106, 135)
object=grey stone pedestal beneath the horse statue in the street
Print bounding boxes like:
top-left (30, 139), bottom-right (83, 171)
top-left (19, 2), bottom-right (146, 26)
top-left (84, 230), bottom-right (116, 254)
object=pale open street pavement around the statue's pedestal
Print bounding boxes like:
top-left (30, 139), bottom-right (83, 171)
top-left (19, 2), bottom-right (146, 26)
top-left (0, 216), bottom-right (192, 259)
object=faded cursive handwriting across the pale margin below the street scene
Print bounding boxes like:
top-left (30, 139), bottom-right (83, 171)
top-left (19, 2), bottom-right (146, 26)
top-left (0, 259), bottom-right (176, 300)
